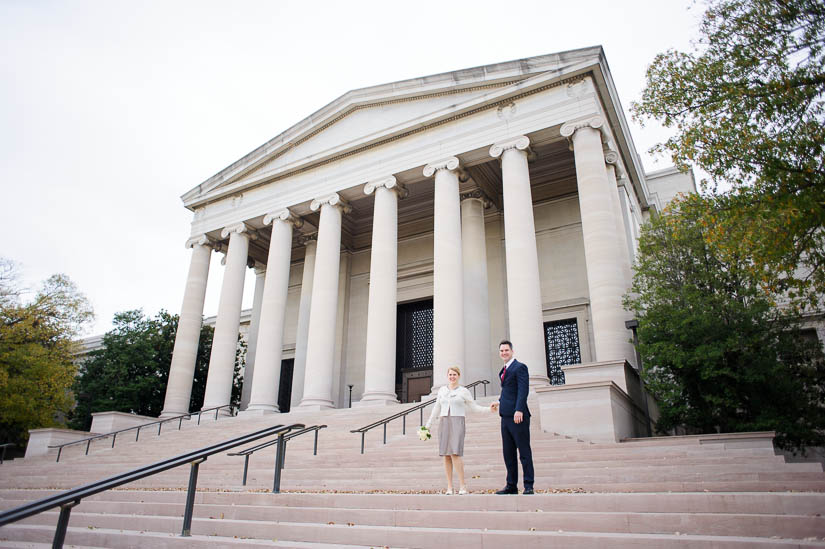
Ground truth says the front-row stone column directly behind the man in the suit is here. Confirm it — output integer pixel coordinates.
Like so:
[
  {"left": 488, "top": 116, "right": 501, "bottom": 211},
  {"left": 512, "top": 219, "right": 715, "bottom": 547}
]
[{"left": 490, "top": 135, "right": 550, "bottom": 386}]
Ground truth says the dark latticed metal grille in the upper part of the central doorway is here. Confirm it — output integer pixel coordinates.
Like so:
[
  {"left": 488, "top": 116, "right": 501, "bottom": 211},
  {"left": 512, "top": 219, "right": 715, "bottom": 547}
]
[{"left": 396, "top": 299, "right": 433, "bottom": 383}]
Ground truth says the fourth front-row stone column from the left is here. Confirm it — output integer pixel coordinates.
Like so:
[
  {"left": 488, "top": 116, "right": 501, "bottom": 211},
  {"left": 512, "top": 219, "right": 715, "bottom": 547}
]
[{"left": 301, "top": 193, "right": 350, "bottom": 408}]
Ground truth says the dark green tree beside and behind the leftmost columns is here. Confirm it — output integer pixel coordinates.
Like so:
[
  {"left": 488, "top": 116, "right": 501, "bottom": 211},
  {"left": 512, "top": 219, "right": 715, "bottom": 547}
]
[{"left": 72, "top": 309, "right": 245, "bottom": 430}]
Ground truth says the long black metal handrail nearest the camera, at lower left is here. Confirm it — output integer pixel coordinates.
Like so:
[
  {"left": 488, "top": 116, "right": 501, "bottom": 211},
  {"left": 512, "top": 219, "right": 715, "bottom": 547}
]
[{"left": 0, "top": 423, "right": 304, "bottom": 549}]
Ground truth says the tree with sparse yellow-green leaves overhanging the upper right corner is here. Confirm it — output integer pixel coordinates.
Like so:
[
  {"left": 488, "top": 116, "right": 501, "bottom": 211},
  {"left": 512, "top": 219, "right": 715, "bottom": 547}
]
[{"left": 632, "top": 0, "right": 825, "bottom": 309}]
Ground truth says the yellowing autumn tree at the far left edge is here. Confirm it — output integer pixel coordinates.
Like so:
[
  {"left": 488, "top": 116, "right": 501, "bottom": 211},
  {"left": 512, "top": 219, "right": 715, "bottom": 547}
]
[{"left": 0, "top": 259, "right": 94, "bottom": 445}]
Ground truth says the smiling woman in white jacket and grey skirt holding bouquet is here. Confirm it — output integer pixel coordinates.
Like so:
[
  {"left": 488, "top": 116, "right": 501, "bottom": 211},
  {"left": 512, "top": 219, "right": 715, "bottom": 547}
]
[{"left": 427, "top": 366, "right": 490, "bottom": 494}]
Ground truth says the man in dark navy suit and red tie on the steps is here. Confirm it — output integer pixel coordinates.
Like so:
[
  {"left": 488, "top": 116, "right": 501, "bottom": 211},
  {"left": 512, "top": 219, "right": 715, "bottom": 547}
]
[{"left": 492, "top": 339, "right": 533, "bottom": 495}]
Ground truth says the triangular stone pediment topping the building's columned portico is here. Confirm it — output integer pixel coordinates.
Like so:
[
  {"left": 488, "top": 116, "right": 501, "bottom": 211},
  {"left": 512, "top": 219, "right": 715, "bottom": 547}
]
[{"left": 182, "top": 46, "right": 603, "bottom": 206}]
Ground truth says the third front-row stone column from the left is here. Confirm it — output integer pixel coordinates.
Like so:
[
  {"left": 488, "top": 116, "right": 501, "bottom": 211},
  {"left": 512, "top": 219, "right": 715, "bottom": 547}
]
[{"left": 248, "top": 210, "right": 303, "bottom": 413}]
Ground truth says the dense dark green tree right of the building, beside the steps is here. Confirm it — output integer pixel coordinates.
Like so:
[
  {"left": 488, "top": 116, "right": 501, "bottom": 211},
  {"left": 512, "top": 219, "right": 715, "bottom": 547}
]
[{"left": 625, "top": 195, "right": 825, "bottom": 449}]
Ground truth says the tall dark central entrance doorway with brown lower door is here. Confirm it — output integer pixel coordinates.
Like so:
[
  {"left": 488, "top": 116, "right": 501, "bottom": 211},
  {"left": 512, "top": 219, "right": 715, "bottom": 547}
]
[{"left": 395, "top": 299, "right": 433, "bottom": 402}]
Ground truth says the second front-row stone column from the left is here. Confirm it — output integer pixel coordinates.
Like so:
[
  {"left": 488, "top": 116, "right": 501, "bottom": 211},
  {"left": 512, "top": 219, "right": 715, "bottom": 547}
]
[{"left": 203, "top": 223, "right": 251, "bottom": 409}]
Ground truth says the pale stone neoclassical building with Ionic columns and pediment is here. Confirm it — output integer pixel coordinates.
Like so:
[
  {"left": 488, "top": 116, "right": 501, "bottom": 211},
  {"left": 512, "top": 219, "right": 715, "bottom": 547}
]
[{"left": 158, "top": 47, "right": 695, "bottom": 432}]
